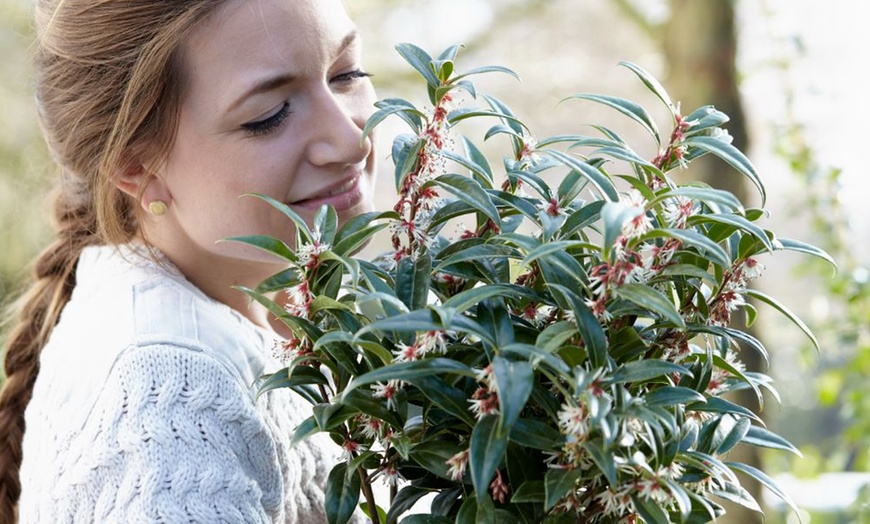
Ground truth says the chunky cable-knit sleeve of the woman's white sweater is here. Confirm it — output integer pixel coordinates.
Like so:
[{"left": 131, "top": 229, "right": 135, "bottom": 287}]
[{"left": 44, "top": 345, "right": 283, "bottom": 523}]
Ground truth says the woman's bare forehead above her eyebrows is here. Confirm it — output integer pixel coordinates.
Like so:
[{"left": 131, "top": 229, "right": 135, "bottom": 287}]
[{"left": 181, "top": 0, "right": 354, "bottom": 106}]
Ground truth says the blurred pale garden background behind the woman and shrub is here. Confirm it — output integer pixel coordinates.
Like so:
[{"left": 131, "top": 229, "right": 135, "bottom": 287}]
[{"left": 0, "top": 0, "right": 870, "bottom": 523}]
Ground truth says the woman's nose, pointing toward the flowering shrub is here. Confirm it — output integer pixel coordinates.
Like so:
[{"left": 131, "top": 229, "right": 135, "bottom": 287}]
[{"left": 308, "top": 89, "right": 372, "bottom": 166}]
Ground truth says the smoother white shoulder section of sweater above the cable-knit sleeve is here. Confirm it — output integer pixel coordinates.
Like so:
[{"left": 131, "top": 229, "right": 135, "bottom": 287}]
[{"left": 29, "top": 246, "right": 267, "bottom": 438}]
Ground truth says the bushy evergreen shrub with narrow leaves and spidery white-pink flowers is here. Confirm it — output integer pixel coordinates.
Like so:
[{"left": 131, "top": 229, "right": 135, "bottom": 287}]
[{"left": 236, "top": 44, "right": 830, "bottom": 523}]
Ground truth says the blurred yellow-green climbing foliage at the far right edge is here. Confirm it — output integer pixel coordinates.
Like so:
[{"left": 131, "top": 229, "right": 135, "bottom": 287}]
[{"left": 777, "top": 44, "right": 870, "bottom": 473}]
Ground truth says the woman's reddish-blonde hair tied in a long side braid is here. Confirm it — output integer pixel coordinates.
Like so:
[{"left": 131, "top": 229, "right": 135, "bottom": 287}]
[{"left": 0, "top": 0, "right": 228, "bottom": 524}]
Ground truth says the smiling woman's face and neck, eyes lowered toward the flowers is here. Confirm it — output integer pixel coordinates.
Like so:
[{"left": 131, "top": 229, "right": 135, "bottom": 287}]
[{"left": 146, "top": 0, "right": 375, "bottom": 283}]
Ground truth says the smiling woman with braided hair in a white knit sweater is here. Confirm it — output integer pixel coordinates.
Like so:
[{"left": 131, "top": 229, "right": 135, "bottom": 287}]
[{"left": 0, "top": 0, "right": 375, "bottom": 523}]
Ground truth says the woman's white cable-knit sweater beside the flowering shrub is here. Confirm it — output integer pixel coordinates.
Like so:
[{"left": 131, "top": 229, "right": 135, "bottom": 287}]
[{"left": 19, "top": 247, "right": 348, "bottom": 523}]
